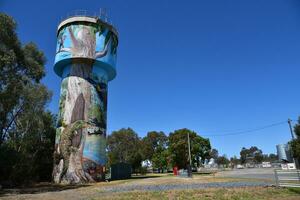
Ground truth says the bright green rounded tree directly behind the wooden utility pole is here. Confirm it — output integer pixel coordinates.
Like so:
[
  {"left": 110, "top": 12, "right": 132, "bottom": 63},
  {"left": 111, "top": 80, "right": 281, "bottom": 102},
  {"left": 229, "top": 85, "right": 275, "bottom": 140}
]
[{"left": 168, "top": 129, "right": 211, "bottom": 168}]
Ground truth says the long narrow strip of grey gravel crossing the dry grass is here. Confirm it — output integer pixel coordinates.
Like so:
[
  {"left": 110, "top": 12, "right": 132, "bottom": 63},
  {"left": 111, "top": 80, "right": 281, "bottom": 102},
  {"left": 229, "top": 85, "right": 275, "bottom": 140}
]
[{"left": 103, "top": 182, "right": 272, "bottom": 192}]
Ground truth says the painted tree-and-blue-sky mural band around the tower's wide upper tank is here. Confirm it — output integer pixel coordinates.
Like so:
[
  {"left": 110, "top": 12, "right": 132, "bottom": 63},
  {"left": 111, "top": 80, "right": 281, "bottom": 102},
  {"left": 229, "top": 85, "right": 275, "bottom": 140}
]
[{"left": 55, "top": 24, "right": 118, "bottom": 64}]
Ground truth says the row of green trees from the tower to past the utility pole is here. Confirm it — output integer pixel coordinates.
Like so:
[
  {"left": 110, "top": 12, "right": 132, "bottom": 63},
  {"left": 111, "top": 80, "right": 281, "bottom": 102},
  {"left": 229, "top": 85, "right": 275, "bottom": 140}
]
[{"left": 107, "top": 128, "right": 211, "bottom": 172}]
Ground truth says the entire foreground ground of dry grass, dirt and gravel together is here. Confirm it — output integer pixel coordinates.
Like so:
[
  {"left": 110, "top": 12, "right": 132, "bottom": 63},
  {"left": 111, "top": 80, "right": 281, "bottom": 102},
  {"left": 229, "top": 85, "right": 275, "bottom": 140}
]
[{"left": 0, "top": 174, "right": 300, "bottom": 200}]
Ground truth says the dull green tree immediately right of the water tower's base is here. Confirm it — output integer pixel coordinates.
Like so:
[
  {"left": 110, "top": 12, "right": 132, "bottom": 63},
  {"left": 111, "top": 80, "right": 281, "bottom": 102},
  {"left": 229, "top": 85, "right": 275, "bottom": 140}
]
[{"left": 107, "top": 128, "right": 143, "bottom": 171}]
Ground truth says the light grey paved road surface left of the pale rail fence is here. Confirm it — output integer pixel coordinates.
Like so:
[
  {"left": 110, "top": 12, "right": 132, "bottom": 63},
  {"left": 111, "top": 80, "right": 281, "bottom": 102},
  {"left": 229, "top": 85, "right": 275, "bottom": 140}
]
[{"left": 218, "top": 168, "right": 275, "bottom": 181}]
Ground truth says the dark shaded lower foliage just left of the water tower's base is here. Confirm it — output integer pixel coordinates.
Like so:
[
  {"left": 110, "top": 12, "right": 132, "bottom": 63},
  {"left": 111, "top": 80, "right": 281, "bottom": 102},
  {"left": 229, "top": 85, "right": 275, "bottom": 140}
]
[{"left": 0, "top": 112, "right": 55, "bottom": 185}]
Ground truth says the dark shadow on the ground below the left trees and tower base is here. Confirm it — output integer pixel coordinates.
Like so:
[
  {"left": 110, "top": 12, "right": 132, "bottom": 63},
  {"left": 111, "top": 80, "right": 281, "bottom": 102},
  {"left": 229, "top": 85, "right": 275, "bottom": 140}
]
[{"left": 0, "top": 183, "right": 90, "bottom": 197}]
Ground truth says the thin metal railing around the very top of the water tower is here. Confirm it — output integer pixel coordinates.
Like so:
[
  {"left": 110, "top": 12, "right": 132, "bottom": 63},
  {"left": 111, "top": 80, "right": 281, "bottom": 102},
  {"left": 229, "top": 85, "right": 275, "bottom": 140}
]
[{"left": 59, "top": 8, "right": 116, "bottom": 28}]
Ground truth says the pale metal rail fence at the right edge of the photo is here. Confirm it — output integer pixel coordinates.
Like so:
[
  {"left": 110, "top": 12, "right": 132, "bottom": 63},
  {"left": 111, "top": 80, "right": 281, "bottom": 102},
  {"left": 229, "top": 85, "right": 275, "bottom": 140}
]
[{"left": 274, "top": 169, "right": 300, "bottom": 187}]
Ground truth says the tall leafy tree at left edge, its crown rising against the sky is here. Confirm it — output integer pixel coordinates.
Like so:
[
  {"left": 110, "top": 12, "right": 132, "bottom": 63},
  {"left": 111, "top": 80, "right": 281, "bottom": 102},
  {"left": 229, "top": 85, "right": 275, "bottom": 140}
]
[{"left": 0, "top": 13, "right": 48, "bottom": 145}]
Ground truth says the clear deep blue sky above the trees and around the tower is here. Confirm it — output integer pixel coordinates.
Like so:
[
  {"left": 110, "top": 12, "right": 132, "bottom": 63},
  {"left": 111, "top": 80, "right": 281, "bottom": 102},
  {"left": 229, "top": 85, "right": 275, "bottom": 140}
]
[{"left": 0, "top": 0, "right": 300, "bottom": 156}]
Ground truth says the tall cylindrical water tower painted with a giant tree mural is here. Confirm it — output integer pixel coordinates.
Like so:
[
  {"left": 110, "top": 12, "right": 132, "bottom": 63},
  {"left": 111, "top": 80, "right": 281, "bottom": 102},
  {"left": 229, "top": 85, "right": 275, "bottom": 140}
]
[{"left": 53, "top": 10, "right": 118, "bottom": 183}]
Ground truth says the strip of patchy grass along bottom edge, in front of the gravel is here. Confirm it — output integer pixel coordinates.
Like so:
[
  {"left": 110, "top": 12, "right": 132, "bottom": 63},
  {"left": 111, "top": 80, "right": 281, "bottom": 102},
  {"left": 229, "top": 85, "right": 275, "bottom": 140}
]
[{"left": 94, "top": 187, "right": 300, "bottom": 200}]
